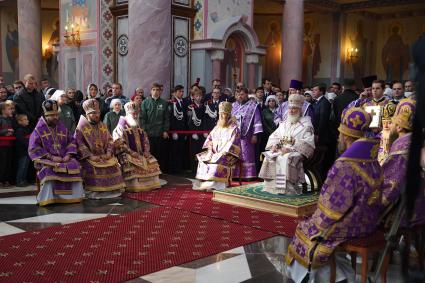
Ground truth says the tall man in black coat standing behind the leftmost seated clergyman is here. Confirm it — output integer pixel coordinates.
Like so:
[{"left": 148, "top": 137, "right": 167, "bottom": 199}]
[{"left": 13, "top": 74, "right": 44, "bottom": 130}]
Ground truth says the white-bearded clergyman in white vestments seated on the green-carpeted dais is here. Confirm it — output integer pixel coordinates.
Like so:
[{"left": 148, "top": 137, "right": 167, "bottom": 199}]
[{"left": 259, "top": 93, "right": 315, "bottom": 195}]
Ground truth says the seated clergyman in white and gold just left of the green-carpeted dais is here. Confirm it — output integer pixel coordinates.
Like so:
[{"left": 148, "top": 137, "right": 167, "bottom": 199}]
[{"left": 193, "top": 102, "right": 241, "bottom": 190}]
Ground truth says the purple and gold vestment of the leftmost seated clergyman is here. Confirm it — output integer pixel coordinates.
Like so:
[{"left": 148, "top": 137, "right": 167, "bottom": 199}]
[{"left": 28, "top": 117, "right": 82, "bottom": 195}]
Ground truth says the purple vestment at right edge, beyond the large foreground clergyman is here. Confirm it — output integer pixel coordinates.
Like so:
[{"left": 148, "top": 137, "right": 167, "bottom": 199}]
[{"left": 382, "top": 133, "right": 425, "bottom": 227}]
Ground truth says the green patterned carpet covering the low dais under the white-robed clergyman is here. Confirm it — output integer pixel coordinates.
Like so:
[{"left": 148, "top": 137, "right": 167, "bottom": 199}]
[{"left": 225, "top": 183, "right": 319, "bottom": 206}]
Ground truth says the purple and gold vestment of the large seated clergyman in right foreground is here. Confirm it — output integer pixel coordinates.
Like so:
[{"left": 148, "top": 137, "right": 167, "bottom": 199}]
[{"left": 286, "top": 139, "right": 383, "bottom": 268}]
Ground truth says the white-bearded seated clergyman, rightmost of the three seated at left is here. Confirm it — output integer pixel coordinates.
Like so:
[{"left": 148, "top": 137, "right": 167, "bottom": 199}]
[{"left": 112, "top": 102, "right": 161, "bottom": 192}]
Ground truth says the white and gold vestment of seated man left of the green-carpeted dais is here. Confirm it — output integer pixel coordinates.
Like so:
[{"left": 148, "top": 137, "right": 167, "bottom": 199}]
[{"left": 196, "top": 123, "right": 241, "bottom": 184}]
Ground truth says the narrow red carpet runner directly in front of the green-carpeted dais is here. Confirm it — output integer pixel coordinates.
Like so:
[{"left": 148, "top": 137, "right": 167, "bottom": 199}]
[{"left": 126, "top": 187, "right": 298, "bottom": 237}]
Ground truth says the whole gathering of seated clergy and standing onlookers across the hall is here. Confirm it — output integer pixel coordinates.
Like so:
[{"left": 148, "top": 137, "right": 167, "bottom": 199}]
[{"left": 0, "top": 69, "right": 425, "bottom": 282}]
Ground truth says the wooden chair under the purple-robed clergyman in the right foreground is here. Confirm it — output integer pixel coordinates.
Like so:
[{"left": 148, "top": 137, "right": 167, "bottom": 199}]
[{"left": 330, "top": 230, "right": 390, "bottom": 283}]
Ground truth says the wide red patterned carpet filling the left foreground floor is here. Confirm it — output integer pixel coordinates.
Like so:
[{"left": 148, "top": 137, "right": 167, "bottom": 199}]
[{"left": 0, "top": 207, "right": 273, "bottom": 282}]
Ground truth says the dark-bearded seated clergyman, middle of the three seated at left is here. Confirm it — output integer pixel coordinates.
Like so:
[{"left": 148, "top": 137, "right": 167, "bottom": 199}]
[{"left": 75, "top": 99, "right": 125, "bottom": 199}]
